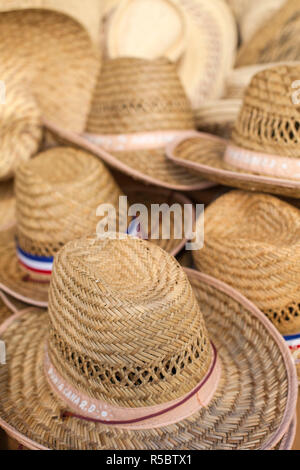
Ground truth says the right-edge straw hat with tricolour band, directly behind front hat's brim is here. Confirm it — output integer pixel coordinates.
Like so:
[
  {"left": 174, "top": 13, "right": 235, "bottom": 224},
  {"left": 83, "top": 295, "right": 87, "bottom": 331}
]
[{"left": 193, "top": 191, "right": 300, "bottom": 377}]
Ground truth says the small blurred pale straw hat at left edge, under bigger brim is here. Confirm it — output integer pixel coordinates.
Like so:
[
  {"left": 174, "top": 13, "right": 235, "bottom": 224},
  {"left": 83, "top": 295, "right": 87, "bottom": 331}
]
[{"left": 0, "top": 66, "right": 42, "bottom": 180}]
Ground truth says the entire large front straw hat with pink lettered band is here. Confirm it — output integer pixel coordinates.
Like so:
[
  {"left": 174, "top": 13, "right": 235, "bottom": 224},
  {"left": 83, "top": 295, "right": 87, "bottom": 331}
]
[{"left": 0, "top": 238, "right": 297, "bottom": 450}]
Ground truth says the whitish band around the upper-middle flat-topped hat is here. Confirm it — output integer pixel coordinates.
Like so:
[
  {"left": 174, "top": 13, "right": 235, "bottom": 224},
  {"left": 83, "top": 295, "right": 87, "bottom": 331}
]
[{"left": 84, "top": 129, "right": 194, "bottom": 152}]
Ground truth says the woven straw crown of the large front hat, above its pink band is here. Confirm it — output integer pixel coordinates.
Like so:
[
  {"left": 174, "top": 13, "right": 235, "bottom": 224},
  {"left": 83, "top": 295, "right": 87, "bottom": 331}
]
[{"left": 48, "top": 238, "right": 212, "bottom": 407}]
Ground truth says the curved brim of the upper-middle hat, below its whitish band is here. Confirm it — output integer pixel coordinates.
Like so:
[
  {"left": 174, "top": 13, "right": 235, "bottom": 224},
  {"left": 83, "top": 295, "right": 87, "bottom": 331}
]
[{"left": 43, "top": 119, "right": 215, "bottom": 191}]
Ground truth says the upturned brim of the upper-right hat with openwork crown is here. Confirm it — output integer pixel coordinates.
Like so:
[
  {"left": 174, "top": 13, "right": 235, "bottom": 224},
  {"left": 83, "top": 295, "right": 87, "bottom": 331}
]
[{"left": 166, "top": 132, "right": 300, "bottom": 198}]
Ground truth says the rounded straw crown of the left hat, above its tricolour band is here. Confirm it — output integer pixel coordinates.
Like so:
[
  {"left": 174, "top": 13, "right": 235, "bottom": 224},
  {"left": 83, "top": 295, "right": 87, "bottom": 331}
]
[{"left": 15, "top": 147, "right": 121, "bottom": 257}]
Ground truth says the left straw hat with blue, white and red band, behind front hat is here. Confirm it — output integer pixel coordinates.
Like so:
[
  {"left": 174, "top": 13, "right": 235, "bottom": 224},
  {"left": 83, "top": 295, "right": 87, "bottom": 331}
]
[{"left": 0, "top": 147, "right": 122, "bottom": 306}]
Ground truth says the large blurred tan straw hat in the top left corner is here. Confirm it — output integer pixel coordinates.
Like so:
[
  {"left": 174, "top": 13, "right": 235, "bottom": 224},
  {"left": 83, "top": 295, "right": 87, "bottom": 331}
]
[{"left": 0, "top": 0, "right": 100, "bottom": 132}]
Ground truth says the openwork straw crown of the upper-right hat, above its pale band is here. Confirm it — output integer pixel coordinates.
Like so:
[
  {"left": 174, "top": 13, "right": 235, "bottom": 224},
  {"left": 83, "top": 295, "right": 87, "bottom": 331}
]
[{"left": 232, "top": 66, "right": 300, "bottom": 158}]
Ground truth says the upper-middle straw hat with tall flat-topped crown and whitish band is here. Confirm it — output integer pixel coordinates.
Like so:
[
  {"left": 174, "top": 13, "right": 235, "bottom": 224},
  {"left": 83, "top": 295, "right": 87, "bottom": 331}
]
[{"left": 45, "top": 58, "right": 211, "bottom": 191}]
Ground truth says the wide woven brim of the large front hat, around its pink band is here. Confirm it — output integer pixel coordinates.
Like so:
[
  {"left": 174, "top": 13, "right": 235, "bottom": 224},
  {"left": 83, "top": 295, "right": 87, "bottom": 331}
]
[{"left": 0, "top": 270, "right": 298, "bottom": 450}]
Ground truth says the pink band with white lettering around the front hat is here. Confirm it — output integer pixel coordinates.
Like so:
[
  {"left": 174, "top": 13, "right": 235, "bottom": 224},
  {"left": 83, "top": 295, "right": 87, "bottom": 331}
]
[{"left": 44, "top": 345, "right": 221, "bottom": 429}]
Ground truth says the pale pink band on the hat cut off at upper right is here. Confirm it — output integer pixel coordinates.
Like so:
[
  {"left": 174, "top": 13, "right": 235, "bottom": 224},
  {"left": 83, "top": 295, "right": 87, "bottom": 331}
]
[{"left": 224, "top": 145, "right": 300, "bottom": 180}]
